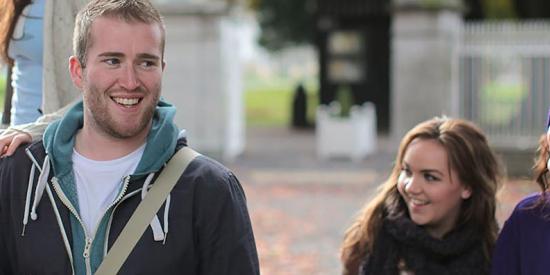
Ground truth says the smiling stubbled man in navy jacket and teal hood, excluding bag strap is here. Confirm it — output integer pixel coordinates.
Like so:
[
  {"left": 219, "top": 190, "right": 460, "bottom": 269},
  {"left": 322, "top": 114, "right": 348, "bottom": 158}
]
[{"left": 0, "top": 0, "right": 259, "bottom": 274}]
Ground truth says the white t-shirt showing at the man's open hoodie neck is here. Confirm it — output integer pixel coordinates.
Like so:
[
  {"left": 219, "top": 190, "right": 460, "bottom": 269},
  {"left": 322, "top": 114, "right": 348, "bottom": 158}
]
[{"left": 72, "top": 144, "right": 145, "bottom": 235}]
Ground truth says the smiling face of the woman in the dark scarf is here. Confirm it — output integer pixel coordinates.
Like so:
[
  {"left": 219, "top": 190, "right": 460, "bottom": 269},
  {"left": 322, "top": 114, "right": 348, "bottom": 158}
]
[{"left": 397, "top": 139, "right": 471, "bottom": 238}]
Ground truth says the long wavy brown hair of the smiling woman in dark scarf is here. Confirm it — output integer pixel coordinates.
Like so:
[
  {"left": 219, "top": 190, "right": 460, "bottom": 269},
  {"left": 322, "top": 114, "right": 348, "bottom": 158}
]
[{"left": 341, "top": 118, "right": 502, "bottom": 274}]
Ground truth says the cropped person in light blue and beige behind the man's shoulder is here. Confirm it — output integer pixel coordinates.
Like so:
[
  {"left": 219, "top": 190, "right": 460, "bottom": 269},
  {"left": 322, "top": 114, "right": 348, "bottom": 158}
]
[{"left": 0, "top": 0, "right": 87, "bottom": 125}]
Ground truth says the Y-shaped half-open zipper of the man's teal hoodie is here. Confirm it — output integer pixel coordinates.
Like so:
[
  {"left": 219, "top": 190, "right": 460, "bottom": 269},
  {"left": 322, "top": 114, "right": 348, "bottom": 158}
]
[{"left": 52, "top": 176, "right": 134, "bottom": 275}]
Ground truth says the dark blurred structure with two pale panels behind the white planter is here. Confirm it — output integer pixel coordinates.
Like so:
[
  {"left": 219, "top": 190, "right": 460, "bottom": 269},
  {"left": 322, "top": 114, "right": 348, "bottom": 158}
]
[{"left": 316, "top": 0, "right": 391, "bottom": 132}]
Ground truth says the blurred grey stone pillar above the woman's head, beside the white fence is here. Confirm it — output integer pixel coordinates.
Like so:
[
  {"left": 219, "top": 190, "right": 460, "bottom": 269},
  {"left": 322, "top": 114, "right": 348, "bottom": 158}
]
[{"left": 390, "top": 0, "right": 463, "bottom": 141}]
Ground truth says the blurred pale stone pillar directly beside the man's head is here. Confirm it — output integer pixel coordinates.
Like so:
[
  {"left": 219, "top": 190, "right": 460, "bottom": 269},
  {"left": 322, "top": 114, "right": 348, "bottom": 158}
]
[{"left": 156, "top": 0, "right": 245, "bottom": 160}]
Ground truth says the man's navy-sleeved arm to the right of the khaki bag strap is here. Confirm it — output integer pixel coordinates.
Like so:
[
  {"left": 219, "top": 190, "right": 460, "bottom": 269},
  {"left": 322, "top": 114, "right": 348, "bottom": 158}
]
[{"left": 196, "top": 167, "right": 260, "bottom": 275}]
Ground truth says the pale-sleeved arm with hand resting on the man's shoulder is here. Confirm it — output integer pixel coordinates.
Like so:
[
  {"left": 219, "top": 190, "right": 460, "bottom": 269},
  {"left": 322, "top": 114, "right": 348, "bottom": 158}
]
[{"left": 0, "top": 103, "right": 73, "bottom": 157}]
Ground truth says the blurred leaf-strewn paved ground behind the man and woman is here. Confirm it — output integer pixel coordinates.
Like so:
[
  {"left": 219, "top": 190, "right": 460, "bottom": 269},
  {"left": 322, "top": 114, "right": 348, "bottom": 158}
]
[{"left": 227, "top": 128, "right": 536, "bottom": 275}]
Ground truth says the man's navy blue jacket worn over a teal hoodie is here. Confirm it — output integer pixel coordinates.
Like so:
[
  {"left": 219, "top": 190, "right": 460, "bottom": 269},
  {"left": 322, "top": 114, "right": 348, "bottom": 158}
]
[{"left": 0, "top": 141, "right": 259, "bottom": 275}]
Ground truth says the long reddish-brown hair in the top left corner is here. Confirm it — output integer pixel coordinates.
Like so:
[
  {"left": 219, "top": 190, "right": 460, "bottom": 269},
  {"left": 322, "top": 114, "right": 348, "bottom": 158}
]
[{"left": 0, "top": 0, "right": 31, "bottom": 65}]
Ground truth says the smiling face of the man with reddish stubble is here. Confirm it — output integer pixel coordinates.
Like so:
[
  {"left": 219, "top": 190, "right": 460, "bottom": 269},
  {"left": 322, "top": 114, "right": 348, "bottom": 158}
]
[{"left": 70, "top": 17, "right": 164, "bottom": 139}]
